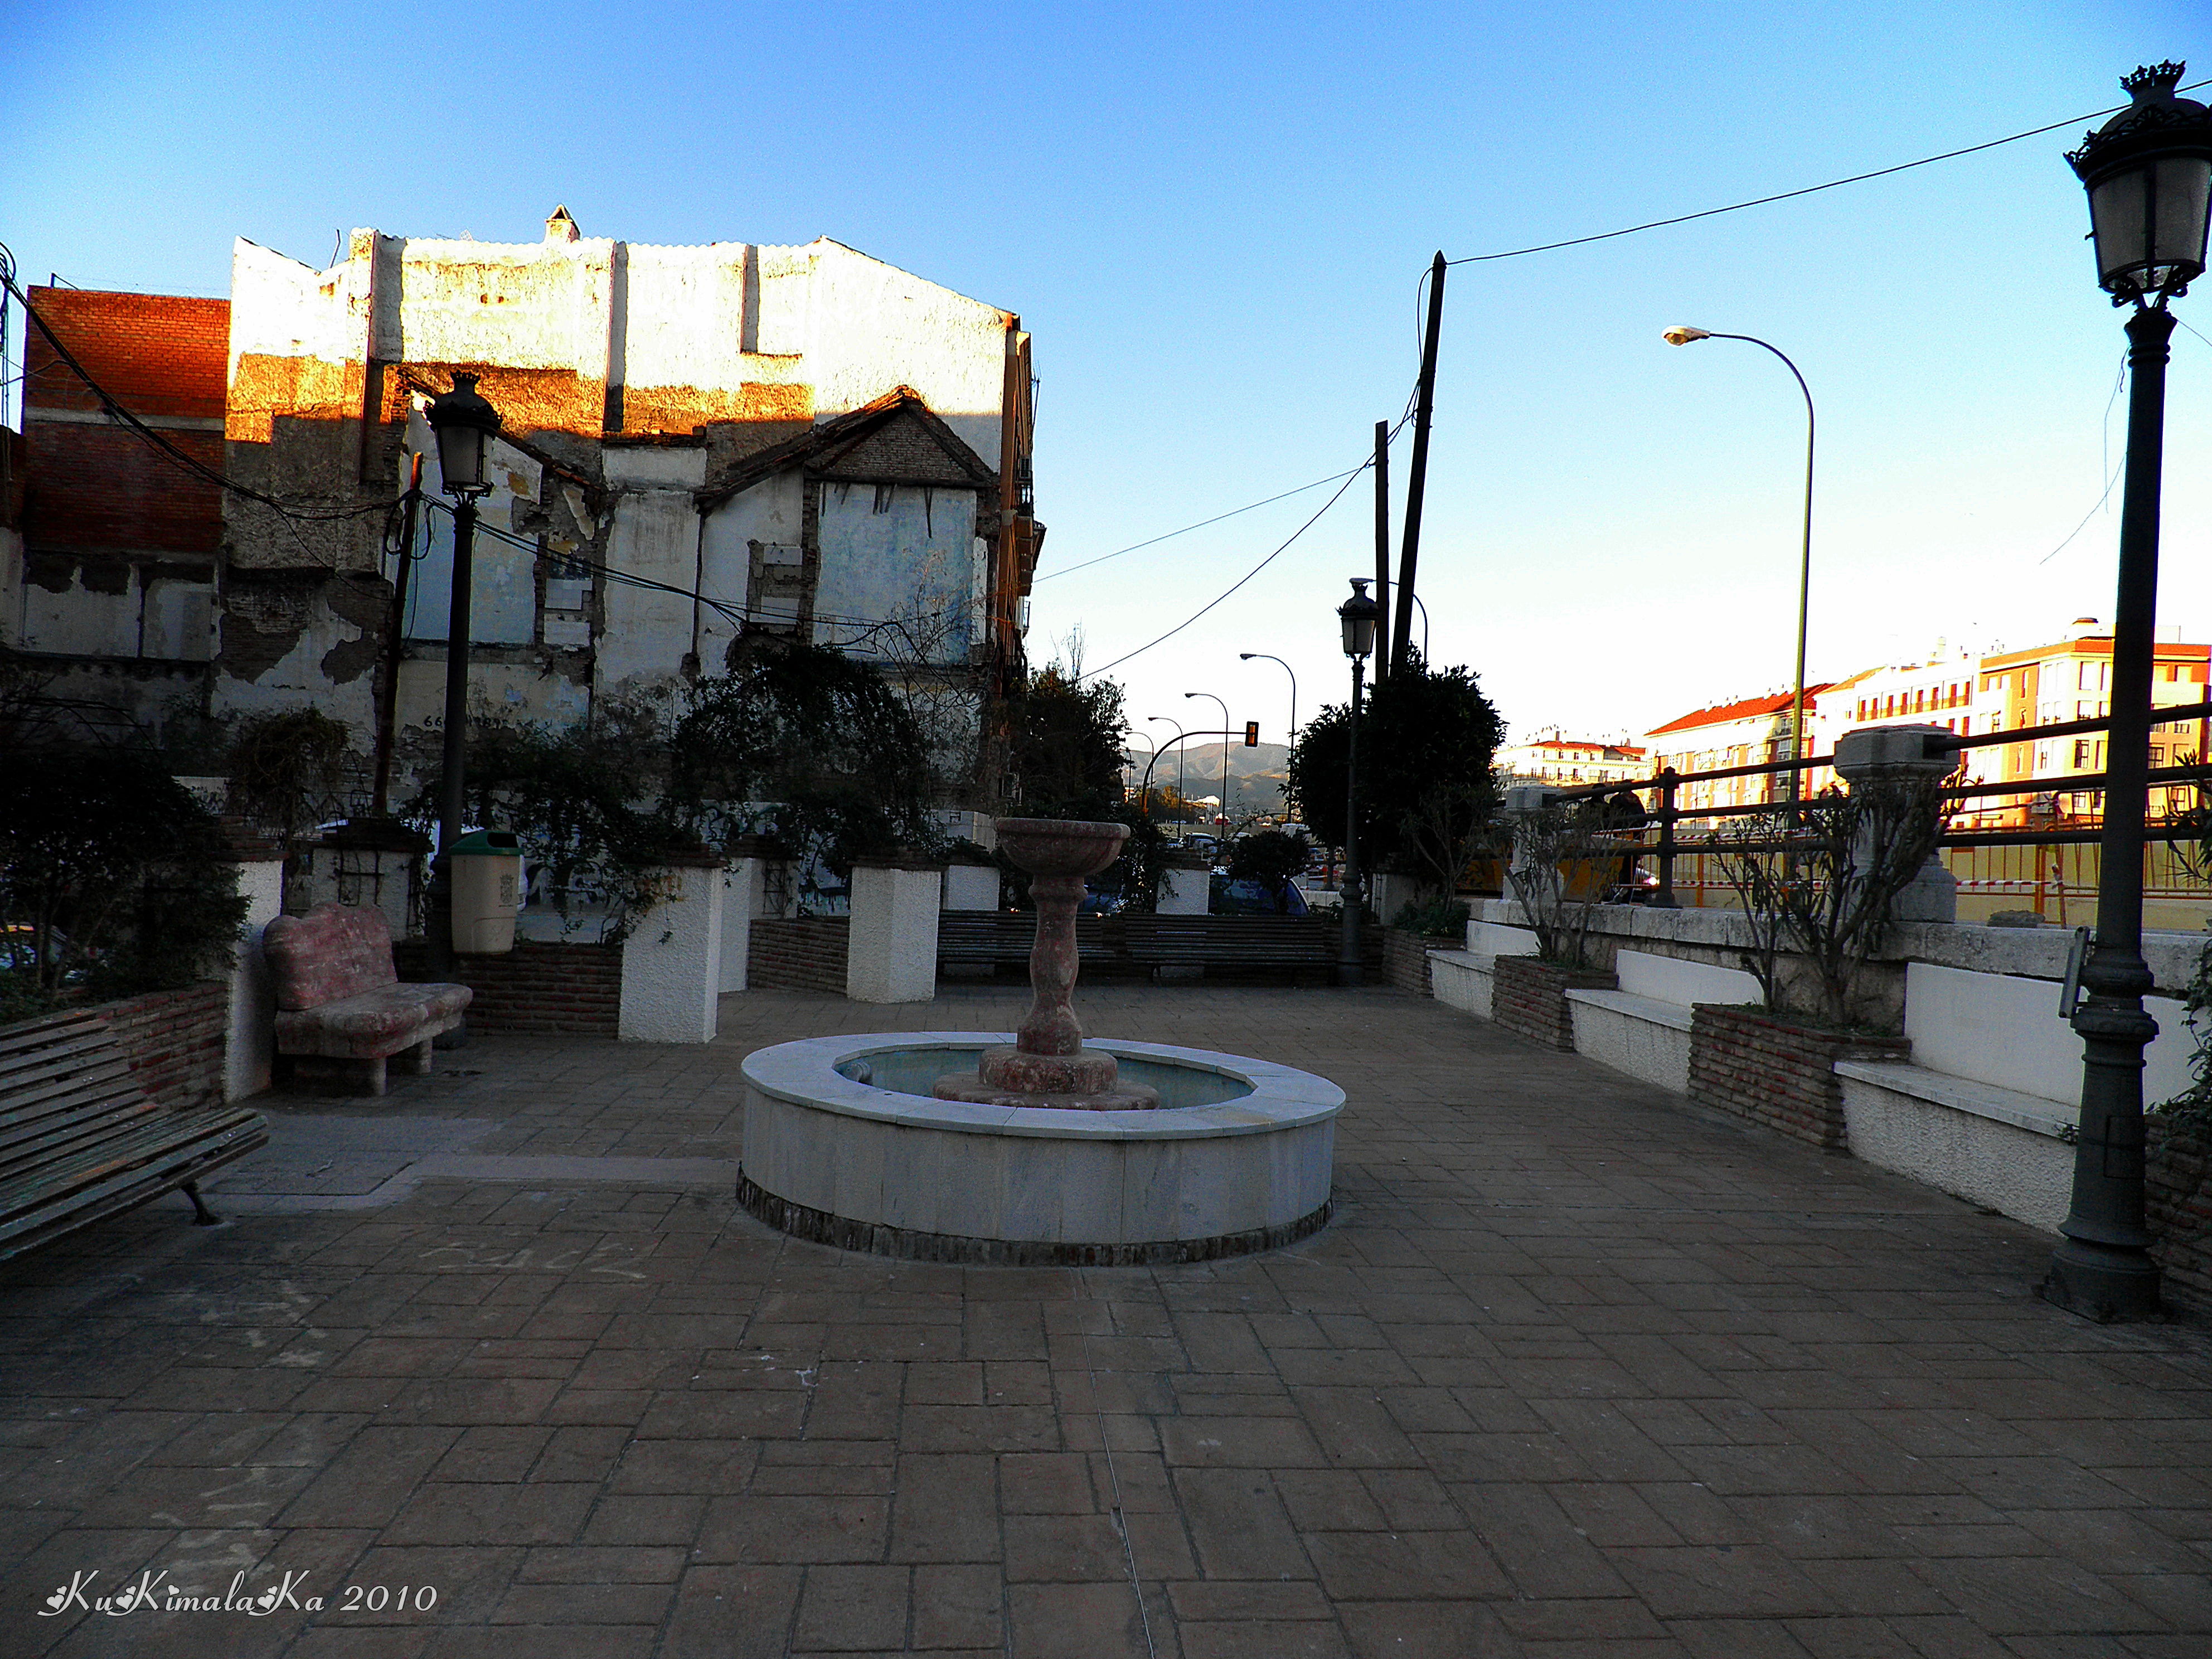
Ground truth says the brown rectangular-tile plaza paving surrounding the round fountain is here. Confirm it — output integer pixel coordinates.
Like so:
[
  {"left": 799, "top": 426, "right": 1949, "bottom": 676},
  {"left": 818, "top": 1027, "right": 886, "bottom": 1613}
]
[{"left": 0, "top": 987, "right": 2212, "bottom": 1659}]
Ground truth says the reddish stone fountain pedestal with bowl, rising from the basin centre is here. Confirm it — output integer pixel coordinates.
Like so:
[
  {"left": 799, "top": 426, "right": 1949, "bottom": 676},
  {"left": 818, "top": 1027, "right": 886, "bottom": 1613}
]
[{"left": 933, "top": 818, "right": 1159, "bottom": 1113}]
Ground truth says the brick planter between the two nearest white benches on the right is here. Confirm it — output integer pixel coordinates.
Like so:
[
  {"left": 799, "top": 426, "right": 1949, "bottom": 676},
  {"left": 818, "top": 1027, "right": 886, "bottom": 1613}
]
[{"left": 1681, "top": 1008, "right": 1911, "bottom": 1152}]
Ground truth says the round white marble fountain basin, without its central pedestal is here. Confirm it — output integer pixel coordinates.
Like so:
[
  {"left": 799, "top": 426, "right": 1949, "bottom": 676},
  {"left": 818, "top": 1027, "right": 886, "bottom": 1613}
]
[{"left": 739, "top": 1031, "right": 1345, "bottom": 1265}]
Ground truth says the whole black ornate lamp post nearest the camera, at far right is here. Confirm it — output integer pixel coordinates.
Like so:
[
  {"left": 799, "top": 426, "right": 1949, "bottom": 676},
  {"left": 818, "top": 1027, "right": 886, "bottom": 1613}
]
[{"left": 2041, "top": 64, "right": 2212, "bottom": 1321}]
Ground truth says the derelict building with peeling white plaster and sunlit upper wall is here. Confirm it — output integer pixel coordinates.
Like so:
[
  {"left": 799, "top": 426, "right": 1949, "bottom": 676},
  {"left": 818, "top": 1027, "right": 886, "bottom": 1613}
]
[{"left": 7, "top": 210, "right": 1042, "bottom": 805}]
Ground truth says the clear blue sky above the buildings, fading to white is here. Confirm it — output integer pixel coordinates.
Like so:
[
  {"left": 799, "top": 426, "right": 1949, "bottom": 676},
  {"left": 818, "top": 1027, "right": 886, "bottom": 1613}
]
[{"left": 0, "top": 0, "right": 2212, "bottom": 739}]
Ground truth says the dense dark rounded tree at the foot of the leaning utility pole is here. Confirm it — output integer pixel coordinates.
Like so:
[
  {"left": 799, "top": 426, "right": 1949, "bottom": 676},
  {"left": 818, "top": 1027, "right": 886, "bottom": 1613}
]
[{"left": 1285, "top": 653, "right": 1504, "bottom": 887}]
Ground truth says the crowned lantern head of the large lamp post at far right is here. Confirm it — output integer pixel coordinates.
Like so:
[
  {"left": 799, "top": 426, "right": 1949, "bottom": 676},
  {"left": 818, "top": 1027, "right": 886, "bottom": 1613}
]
[{"left": 2066, "top": 64, "right": 2212, "bottom": 305}]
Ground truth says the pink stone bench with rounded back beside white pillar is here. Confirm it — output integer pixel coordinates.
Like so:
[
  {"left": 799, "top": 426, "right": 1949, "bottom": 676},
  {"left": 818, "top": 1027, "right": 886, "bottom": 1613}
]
[{"left": 261, "top": 905, "right": 476, "bottom": 1095}]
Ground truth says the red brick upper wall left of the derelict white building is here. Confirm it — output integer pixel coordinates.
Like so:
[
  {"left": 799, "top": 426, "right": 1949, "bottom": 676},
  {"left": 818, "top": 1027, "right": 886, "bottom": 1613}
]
[{"left": 25, "top": 288, "right": 230, "bottom": 555}]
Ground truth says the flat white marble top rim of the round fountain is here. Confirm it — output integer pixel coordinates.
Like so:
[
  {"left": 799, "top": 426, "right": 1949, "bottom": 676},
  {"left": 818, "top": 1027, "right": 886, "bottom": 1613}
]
[{"left": 743, "top": 1031, "right": 1345, "bottom": 1141}]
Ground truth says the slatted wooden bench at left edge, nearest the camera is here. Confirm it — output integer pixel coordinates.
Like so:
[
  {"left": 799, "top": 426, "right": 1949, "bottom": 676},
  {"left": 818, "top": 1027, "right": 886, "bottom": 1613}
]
[{"left": 0, "top": 1013, "right": 270, "bottom": 1259}]
